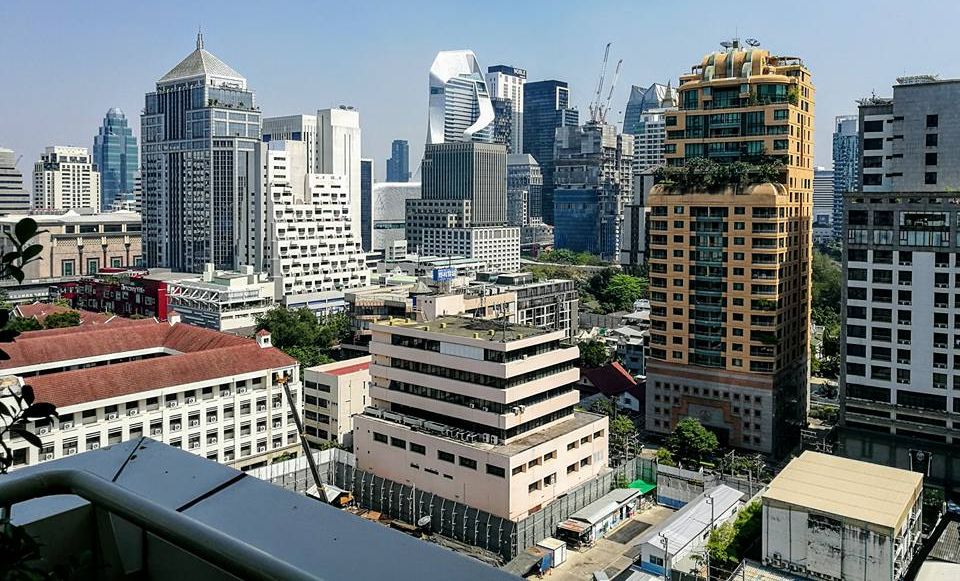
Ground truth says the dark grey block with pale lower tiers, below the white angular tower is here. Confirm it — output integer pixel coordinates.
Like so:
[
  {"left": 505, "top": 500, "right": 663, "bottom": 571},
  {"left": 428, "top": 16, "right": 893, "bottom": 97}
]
[{"left": 406, "top": 142, "right": 520, "bottom": 272}]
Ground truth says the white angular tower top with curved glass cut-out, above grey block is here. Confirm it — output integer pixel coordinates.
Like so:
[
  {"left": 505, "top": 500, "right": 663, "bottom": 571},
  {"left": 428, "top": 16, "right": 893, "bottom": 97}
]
[{"left": 427, "top": 50, "right": 494, "bottom": 144}]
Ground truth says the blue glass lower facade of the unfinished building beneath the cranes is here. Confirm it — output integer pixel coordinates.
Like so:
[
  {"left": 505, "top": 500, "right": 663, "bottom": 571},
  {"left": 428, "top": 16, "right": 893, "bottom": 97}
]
[{"left": 553, "top": 189, "right": 601, "bottom": 255}]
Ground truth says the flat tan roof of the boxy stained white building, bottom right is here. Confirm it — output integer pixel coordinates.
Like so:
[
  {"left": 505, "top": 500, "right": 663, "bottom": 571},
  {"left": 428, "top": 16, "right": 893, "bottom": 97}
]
[{"left": 763, "top": 451, "right": 923, "bottom": 530}]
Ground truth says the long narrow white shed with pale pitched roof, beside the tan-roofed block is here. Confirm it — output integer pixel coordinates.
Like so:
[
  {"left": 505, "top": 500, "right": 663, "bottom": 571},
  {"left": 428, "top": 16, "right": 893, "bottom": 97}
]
[{"left": 637, "top": 484, "right": 744, "bottom": 575}]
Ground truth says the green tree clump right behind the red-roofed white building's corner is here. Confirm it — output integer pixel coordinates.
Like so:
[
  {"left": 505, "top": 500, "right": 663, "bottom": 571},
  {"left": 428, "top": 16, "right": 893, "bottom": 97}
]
[{"left": 257, "top": 307, "right": 353, "bottom": 367}]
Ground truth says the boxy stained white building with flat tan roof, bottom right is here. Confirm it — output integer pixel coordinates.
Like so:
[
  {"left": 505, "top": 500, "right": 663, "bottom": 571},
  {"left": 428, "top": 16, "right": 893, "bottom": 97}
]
[{"left": 763, "top": 451, "right": 923, "bottom": 581}]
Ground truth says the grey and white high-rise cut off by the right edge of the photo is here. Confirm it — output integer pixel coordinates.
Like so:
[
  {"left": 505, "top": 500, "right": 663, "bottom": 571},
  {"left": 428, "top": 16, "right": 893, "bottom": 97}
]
[{"left": 840, "top": 76, "right": 960, "bottom": 489}]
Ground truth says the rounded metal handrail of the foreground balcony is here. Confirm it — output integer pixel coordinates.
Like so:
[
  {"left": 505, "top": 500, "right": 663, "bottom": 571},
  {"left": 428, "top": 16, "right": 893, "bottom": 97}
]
[{"left": 0, "top": 469, "right": 317, "bottom": 581}]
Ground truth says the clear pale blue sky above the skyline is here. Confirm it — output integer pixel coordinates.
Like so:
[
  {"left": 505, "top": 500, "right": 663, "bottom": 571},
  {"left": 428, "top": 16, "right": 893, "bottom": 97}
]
[{"left": 0, "top": 0, "right": 960, "bottom": 180}]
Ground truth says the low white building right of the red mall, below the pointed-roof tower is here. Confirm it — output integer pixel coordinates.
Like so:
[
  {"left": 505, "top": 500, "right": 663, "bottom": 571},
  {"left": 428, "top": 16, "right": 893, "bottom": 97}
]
[{"left": 167, "top": 264, "right": 276, "bottom": 333}]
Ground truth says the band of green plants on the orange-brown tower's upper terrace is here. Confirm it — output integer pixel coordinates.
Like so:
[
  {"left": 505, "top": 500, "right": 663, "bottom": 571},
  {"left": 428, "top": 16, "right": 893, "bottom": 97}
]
[{"left": 654, "top": 157, "right": 786, "bottom": 192}]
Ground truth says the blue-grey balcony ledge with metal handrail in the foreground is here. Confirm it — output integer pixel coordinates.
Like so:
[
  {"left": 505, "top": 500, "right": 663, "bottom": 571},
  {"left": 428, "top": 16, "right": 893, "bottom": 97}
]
[{"left": 0, "top": 439, "right": 512, "bottom": 581}]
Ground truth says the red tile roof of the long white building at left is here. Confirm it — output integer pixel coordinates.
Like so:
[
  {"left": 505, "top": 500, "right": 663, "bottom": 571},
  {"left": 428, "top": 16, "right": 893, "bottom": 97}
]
[{"left": 0, "top": 320, "right": 297, "bottom": 407}]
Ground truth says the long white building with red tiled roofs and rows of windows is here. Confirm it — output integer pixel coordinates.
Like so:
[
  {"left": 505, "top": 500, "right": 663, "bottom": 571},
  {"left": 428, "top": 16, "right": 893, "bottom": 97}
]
[{"left": 0, "top": 316, "right": 300, "bottom": 468}]
